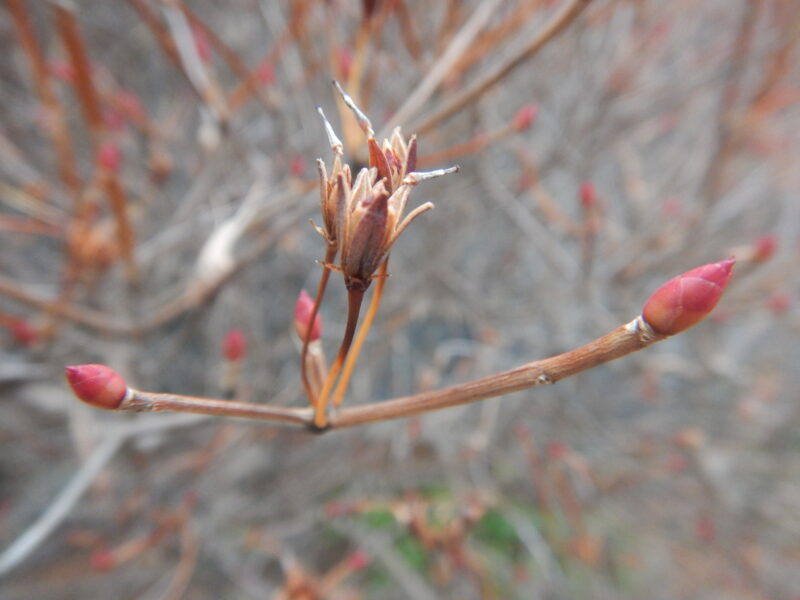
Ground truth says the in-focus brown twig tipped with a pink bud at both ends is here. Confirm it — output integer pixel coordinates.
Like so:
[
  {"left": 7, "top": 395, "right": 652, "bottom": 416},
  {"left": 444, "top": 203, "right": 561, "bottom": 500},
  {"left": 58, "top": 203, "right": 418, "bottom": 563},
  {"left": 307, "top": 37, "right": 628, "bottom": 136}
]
[{"left": 66, "top": 259, "right": 734, "bottom": 433}]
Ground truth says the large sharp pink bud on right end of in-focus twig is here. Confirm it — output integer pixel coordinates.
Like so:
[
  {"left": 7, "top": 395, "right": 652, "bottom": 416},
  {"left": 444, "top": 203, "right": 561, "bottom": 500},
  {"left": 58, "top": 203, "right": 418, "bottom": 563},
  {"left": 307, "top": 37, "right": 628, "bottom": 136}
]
[{"left": 642, "top": 258, "right": 736, "bottom": 335}]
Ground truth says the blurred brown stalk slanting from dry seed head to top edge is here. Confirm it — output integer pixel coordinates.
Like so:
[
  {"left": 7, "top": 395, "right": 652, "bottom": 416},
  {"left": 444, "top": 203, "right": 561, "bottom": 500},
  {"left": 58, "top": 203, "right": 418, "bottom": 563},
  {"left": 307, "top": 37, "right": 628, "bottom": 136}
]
[{"left": 412, "top": 0, "right": 591, "bottom": 134}]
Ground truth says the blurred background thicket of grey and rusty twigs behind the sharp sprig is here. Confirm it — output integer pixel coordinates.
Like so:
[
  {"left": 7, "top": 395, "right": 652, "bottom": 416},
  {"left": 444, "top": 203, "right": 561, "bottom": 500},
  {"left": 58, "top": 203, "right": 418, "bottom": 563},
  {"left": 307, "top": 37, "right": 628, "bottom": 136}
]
[{"left": 0, "top": 0, "right": 800, "bottom": 600}]
